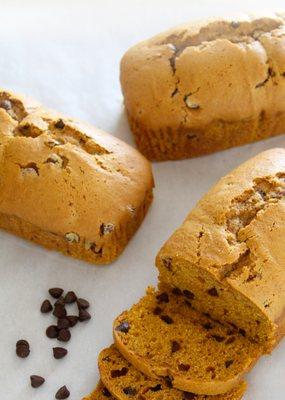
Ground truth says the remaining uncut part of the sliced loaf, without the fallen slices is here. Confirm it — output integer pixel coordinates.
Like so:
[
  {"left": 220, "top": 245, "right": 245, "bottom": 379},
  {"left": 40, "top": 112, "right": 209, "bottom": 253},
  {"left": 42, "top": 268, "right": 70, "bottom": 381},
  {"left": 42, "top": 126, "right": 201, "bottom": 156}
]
[{"left": 156, "top": 149, "right": 285, "bottom": 352}]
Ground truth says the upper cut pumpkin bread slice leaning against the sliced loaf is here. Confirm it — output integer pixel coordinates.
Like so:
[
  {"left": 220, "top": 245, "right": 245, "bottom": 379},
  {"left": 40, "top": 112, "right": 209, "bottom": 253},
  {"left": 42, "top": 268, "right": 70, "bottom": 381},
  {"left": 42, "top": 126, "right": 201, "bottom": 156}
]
[{"left": 113, "top": 286, "right": 260, "bottom": 395}]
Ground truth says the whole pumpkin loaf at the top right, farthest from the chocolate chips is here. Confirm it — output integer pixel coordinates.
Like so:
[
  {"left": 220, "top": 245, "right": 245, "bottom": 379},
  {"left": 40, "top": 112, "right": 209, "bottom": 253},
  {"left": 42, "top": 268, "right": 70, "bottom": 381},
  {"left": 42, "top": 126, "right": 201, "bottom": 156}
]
[{"left": 121, "top": 14, "right": 285, "bottom": 160}]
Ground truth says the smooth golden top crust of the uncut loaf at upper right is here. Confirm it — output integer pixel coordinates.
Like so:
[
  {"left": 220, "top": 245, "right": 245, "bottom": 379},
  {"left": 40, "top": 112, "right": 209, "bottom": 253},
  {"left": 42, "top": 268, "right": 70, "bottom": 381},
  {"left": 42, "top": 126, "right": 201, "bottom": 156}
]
[{"left": 121, "top": 14, "right": 285, "bottom": 130}]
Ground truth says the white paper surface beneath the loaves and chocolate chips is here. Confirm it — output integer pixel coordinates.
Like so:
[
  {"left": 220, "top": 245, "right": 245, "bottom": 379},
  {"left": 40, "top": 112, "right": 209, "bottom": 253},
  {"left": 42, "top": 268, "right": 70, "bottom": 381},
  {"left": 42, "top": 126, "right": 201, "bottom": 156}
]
[{"left": 0, "top": 0, "right": 285, "bottom": 400}]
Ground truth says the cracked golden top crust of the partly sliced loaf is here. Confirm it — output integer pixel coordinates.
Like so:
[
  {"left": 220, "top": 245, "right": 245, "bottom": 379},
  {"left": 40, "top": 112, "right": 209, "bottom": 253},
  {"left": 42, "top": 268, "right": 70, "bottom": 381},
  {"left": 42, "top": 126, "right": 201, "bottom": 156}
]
[{"left": 157, "top": 149, "right": 285, "bottom": 323}]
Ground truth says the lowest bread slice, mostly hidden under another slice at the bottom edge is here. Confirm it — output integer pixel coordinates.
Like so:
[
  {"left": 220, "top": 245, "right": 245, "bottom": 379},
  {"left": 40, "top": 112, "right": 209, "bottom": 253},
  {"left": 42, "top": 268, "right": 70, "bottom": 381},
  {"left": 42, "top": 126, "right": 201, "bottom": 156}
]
[{"left": 97, "top": 346, "right": 246, "bottom": 400}]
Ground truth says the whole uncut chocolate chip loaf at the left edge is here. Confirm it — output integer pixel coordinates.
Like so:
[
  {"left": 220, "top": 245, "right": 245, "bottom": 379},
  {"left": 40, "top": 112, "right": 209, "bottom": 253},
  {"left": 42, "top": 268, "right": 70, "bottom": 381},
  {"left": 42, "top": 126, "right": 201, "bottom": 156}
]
[{"left": 0, "top": 91, "right": 153, "bottom": 264}]
